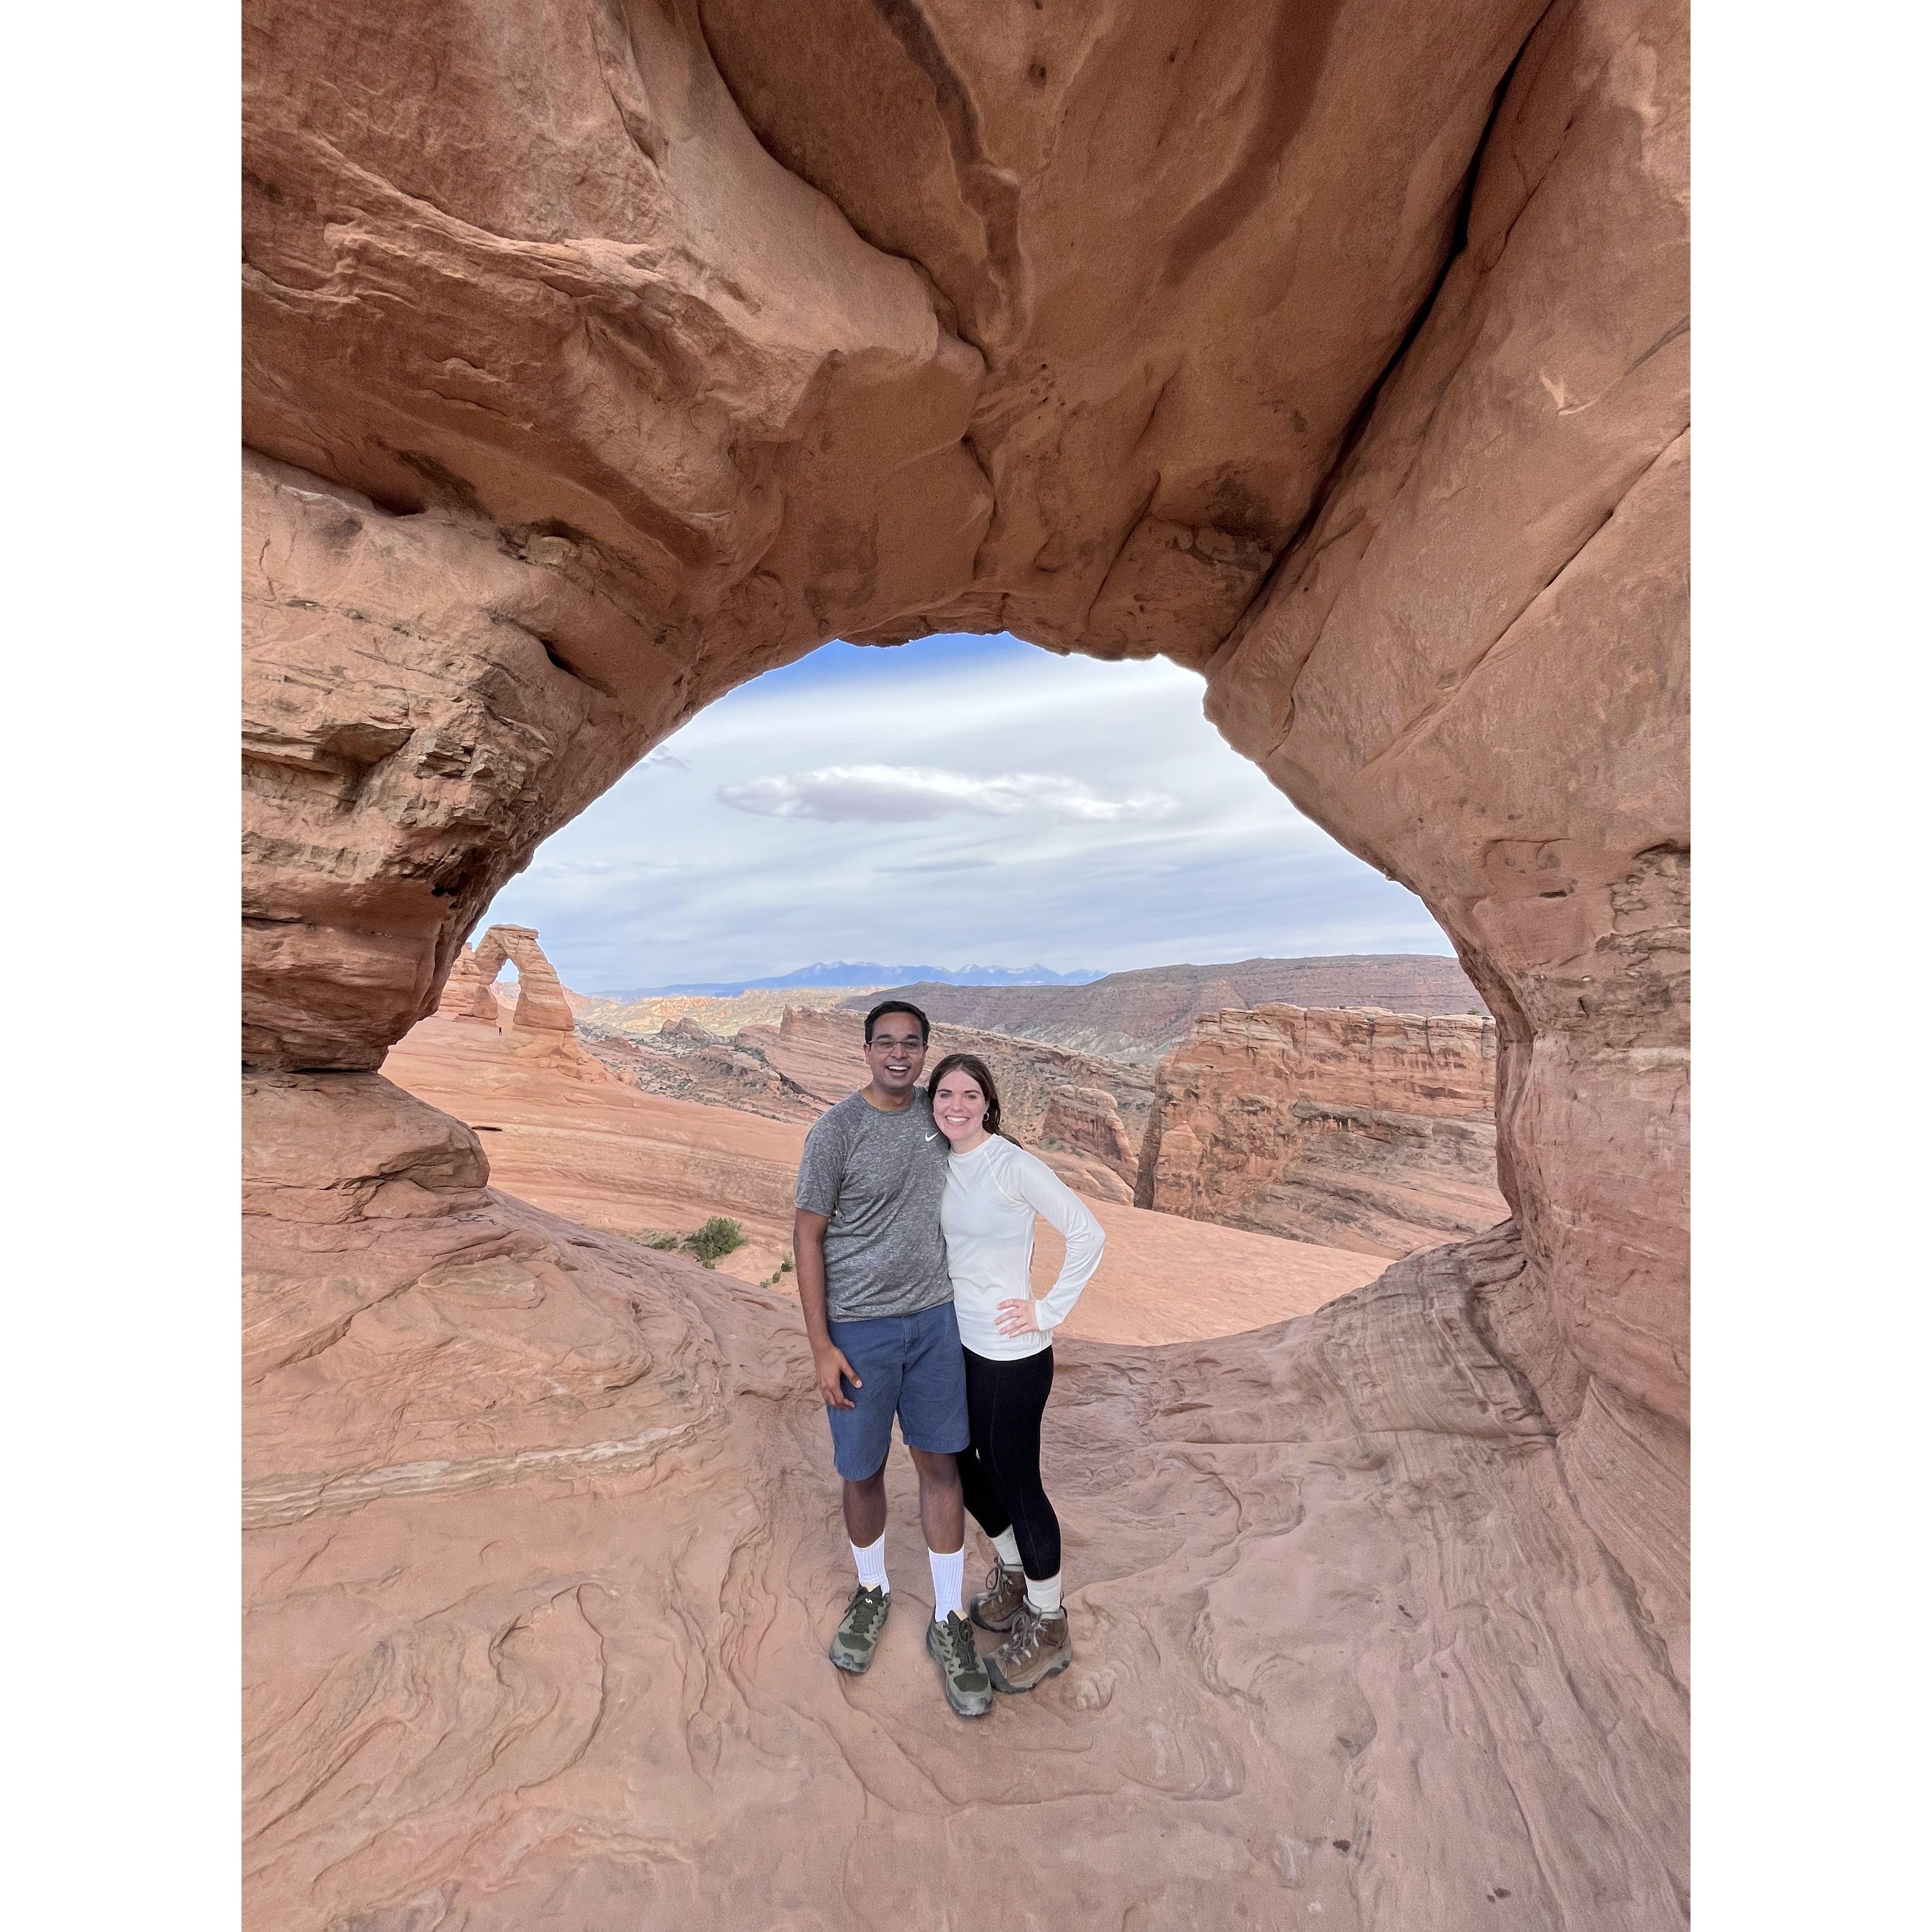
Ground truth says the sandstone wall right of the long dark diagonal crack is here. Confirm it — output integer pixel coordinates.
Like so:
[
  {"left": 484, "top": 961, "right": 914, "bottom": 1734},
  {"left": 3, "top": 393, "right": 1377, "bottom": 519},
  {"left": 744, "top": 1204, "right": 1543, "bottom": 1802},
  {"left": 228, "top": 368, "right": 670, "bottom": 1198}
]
[{"left": 1208, "top": 0, "right": 1690, "bottom": 1424}]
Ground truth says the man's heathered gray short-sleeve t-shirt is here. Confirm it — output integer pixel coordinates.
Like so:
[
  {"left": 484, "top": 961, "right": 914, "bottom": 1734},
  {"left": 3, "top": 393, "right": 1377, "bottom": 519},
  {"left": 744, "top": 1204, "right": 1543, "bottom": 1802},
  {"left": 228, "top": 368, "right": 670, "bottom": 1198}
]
[{"left": 798, "top": 1093, "right": 953, "bottom": 1322}]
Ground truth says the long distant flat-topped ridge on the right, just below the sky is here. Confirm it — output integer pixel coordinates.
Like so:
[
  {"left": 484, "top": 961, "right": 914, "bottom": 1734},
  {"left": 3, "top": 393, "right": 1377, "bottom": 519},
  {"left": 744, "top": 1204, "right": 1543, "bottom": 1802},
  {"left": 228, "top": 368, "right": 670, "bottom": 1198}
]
[{"left": 846, "top": 953, "right": 1482, "bottom": 1067}]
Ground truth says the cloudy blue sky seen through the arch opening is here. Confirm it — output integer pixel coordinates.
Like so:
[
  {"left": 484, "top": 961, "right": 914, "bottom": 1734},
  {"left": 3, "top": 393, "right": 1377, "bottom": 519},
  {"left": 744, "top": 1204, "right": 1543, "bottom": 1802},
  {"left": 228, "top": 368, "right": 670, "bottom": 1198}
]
[{"left": 489, "top": 636, "right": 1451, "bottom": 993}]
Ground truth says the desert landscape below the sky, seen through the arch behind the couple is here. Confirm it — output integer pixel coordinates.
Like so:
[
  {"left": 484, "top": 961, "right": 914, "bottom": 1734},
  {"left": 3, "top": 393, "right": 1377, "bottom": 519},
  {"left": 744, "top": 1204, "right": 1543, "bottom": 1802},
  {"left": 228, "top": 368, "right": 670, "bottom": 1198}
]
[{"left": 384, "top": 929, "right": 1509, "bottom": 1343}]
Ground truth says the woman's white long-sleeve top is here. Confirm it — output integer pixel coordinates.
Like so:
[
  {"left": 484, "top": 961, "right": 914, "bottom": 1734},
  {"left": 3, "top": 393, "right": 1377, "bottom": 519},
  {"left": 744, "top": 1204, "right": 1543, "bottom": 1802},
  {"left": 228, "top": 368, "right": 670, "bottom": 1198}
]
[{"left": 939, "top": 1134, "right": 1107, "bottom": 1362}]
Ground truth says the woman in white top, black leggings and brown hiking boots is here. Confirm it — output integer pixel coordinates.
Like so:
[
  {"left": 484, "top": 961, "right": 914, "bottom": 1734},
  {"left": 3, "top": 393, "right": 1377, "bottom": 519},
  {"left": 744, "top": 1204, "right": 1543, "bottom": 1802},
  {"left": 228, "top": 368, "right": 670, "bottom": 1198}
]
[{"left": 927, "top": 1053, "right": 1107, "bottom": 1690}]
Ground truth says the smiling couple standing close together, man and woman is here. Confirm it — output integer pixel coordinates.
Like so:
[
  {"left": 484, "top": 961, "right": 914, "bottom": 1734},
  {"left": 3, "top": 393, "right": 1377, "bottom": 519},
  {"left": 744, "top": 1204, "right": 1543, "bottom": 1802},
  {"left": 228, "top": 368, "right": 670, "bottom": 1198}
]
[{"left": 794, "top": 999, "right": 1107, "bottom": 1717}]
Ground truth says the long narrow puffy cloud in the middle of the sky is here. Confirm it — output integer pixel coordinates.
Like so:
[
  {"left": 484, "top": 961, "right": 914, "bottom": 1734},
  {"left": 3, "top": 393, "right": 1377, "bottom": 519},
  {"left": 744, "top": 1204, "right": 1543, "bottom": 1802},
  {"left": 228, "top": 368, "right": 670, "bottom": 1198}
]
[{"left": 717, "top": 765, "right": 1174, "bottom": 825}]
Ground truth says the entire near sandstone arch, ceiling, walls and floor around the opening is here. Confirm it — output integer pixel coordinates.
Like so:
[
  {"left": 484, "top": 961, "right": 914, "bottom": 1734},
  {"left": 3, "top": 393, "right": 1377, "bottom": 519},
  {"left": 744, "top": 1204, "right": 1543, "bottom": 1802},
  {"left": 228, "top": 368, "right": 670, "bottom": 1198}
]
[{"left": 243, "top": 0, "right": 1689, "bottom": 1932}]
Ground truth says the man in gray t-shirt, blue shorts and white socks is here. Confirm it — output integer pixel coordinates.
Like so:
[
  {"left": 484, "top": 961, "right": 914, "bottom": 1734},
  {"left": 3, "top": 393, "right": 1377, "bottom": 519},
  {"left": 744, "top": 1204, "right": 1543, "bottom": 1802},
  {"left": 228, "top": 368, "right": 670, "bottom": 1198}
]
[{"left": 792, "top": 999, "right": 993, "bottom": 1717}]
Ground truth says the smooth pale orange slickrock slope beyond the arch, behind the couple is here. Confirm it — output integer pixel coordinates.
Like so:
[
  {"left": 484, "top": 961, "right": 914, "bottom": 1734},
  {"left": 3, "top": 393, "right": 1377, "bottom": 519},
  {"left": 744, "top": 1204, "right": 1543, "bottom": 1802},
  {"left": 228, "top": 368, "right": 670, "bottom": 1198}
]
[{"left": 382, "top": 1020, "right": 1387, "bottom": 1343}]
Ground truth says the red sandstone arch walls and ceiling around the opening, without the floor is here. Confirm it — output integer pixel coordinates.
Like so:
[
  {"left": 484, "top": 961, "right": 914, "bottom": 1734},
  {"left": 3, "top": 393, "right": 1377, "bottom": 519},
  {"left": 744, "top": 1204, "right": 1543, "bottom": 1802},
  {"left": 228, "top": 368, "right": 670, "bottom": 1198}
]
[{"left": 243, "top": 0, "right": 1689, "bottom": 1924}]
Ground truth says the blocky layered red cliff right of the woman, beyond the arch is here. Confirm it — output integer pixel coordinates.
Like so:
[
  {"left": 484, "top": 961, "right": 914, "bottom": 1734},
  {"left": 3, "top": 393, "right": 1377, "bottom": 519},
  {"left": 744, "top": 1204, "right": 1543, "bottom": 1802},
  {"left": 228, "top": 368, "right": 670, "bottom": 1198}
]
[{"left": 1134, "top": 1007, "right": 1509, "bottom": 1260}]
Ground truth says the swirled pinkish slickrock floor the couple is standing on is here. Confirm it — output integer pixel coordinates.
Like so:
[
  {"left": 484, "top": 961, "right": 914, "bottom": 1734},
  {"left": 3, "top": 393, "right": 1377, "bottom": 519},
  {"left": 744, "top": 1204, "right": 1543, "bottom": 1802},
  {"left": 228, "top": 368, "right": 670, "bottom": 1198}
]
[{"left": 245, "top": 1081, "right": 1687, "bottom": 1932}]
